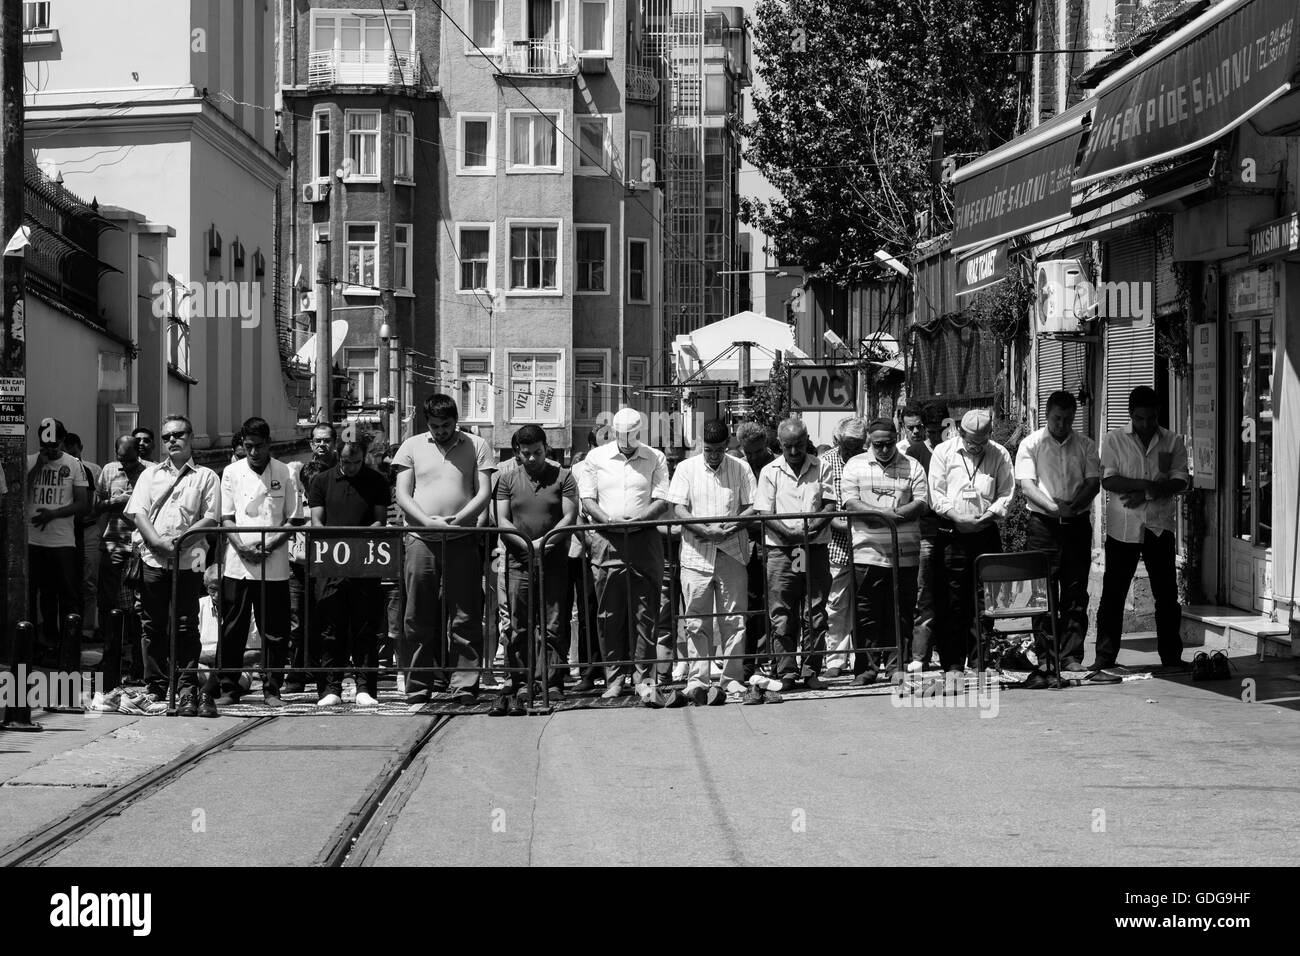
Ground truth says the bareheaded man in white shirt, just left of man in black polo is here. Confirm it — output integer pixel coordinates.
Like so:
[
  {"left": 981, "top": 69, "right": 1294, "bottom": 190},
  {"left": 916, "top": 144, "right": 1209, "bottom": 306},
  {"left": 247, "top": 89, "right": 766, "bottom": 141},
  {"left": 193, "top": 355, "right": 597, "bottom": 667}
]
[{"left": 208, "top": 418, "right": 306, "bottom": 708}]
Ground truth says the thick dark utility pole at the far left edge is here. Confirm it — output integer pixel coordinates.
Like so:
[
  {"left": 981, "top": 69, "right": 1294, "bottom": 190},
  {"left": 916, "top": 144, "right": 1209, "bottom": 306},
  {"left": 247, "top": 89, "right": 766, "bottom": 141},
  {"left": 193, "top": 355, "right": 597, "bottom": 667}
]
[{"left": 0, "top": 3, "right": 27, "bottom": 650}]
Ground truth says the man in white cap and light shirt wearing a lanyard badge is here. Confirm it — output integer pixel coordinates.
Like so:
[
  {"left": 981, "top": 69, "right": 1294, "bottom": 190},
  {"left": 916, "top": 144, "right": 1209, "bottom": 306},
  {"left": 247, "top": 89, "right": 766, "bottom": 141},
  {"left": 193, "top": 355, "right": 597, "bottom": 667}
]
[{"left": 930, "top": 408, "right": 1015, "bottom": 675}]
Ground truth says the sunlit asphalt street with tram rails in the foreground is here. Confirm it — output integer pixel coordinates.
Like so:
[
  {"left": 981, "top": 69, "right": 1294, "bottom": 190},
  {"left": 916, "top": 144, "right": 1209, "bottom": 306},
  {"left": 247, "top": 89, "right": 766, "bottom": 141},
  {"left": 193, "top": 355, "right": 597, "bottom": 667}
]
[{"left": 0, "top": 657, "right": 1300, "bottom": 866}]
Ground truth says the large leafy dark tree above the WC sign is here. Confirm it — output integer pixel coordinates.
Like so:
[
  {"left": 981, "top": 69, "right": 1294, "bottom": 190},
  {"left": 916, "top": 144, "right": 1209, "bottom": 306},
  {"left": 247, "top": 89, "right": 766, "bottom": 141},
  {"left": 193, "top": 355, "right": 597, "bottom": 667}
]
[{"left": 741, "top": 0, "right": 1034, "bottom": 282}]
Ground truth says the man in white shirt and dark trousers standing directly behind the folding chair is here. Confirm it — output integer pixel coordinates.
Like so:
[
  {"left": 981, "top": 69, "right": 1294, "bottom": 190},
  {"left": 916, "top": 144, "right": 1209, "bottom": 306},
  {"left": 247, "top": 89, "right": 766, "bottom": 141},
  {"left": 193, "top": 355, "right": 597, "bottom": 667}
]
[{"left": 1015, "top": 392, "right": 1114, "bottom": 688}]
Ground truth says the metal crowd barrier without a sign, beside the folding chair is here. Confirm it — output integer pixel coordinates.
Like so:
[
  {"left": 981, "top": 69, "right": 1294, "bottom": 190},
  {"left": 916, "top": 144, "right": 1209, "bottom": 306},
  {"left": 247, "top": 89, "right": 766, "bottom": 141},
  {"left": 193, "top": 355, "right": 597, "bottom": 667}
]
[{"left": 529, "top": 511, "right": 910, "bottom": 708}]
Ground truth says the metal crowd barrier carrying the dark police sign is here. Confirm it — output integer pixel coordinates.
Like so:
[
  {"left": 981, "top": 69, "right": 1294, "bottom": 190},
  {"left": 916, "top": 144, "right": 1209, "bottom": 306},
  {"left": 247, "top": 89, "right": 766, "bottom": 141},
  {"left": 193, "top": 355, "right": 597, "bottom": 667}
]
[{"left": 170, "top": 525, "right": 540, "bottom": 714}]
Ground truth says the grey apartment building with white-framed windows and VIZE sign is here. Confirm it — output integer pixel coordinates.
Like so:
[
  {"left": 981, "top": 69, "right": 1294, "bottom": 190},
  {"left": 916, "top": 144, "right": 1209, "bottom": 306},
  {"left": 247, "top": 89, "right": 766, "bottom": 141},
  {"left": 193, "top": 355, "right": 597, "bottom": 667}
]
[{"left": 439, "top": 0, "right": 663, "bottom": 451}]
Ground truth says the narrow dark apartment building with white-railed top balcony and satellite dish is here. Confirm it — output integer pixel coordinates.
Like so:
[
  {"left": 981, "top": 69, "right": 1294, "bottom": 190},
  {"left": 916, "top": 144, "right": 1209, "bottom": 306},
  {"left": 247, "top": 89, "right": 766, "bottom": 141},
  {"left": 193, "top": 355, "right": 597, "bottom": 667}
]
[{"left": 277, "top": 0, "right": 442, "bottom": 440}]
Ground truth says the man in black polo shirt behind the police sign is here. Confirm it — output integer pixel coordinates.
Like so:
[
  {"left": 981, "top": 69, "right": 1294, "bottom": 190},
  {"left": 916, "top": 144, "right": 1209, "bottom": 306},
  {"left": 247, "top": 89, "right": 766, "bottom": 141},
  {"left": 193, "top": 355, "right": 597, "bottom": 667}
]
[{"left": 307, "top": 441, "right": 393, "bottom": 708}]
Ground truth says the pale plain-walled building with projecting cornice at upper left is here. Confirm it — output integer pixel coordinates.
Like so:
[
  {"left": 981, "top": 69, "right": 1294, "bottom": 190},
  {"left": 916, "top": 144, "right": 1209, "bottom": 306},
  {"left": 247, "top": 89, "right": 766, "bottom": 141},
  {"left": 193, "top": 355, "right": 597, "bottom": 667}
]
[{"left": 23, "top": 0, "right": 298, "bottom": 447}]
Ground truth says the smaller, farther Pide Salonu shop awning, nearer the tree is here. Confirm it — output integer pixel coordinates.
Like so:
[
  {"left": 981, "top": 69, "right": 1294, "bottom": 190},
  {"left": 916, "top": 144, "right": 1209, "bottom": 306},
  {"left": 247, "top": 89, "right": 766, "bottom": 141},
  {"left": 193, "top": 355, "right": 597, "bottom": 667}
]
[{"left": 953, "top": 98, "right": 1096, "bottom": 254}]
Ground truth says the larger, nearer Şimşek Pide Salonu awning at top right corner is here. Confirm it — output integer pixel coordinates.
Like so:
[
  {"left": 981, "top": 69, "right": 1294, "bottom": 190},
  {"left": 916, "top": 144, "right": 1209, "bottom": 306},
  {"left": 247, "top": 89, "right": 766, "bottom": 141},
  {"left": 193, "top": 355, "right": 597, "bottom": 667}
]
[{"left": 1074, "top": 0, "right": 1300, "bottom": 186}]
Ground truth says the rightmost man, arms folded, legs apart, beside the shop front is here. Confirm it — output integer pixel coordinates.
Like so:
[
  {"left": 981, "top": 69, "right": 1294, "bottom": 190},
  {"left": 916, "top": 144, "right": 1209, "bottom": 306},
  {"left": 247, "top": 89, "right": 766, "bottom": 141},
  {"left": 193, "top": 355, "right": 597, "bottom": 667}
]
[{"left": 1089, "top": 385, "right": 1188, "bottom": 670}]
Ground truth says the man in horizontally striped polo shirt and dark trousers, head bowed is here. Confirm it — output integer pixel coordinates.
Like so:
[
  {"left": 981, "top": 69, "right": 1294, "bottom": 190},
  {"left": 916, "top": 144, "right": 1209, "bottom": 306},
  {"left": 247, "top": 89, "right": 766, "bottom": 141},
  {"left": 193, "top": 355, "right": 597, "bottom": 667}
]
[{"left": 840, "top": 419, "right": 930, "bottom": 687}]
